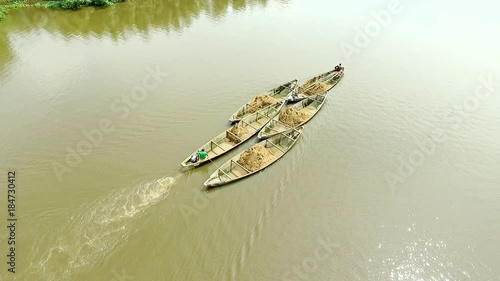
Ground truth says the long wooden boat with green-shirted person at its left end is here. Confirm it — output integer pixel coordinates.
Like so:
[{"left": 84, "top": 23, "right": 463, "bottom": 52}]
[{"left": 181, "top": 101, "right": 285, "bottom": 167}]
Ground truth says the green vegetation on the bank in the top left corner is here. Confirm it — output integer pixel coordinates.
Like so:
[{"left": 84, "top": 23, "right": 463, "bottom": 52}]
[{"left": 0, "top": 0, "right": 124, "bottom": 20}]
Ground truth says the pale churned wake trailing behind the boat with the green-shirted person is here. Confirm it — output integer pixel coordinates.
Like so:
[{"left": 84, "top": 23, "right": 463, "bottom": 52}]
[{"left": 20, "top": 176, "right": 179, "bottom": 280}]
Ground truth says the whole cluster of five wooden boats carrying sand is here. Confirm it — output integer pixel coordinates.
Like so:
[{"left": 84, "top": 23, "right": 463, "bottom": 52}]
[{"left": 181, "top": 66, "right": 344, "bottom": 188}]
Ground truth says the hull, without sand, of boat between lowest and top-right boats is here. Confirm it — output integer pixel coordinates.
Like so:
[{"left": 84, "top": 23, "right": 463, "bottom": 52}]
[{"left": 257, "top": 92, "right": 327, "bottom": 140}]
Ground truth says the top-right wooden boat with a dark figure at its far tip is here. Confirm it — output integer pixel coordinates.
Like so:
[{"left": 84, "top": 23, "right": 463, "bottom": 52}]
[{"left": 287, "top": 68, "right": 344, "bottom": 103}]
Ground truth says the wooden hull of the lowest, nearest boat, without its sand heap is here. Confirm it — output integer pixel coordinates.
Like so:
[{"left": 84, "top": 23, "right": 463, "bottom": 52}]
[{"left": 204, "top": 127, "right": 304, "bottom": 188}]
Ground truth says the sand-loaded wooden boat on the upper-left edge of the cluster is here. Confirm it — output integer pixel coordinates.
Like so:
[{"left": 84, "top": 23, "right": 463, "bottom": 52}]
[{"left": 229, "top": 80, "right": 297, "bottom": 122}]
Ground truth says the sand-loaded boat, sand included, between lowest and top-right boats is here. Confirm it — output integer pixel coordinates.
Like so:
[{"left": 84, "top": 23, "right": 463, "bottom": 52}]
[{"left": 257, "top": 92, "right": 327, "bottom": 140}]
